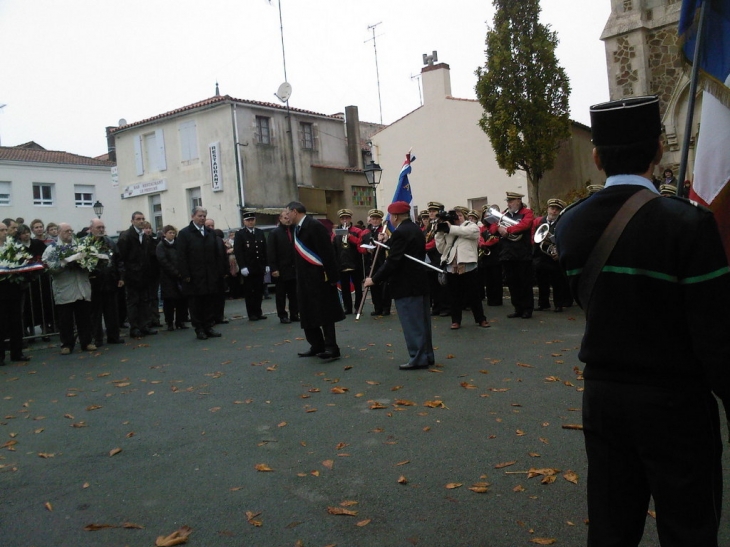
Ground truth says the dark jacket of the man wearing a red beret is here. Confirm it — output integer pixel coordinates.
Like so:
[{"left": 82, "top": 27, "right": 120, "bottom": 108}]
[{"left": 372, "top": 218, "right": 429, "bottom": 299}]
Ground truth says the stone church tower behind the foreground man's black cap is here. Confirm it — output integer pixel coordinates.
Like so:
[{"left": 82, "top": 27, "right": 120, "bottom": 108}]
[{"left": 601, "top": 0, "right": 702, "bottom": 176}]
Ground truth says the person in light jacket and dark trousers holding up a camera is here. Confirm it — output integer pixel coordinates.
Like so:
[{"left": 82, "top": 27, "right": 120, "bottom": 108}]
[{"left": 435, "top": 207, "right": 489, "bottom": 330}]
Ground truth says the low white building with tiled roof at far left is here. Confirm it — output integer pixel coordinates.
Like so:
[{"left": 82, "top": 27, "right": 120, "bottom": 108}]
[{"left": 0, "top": 142, "right": 119, "bottom": 234}]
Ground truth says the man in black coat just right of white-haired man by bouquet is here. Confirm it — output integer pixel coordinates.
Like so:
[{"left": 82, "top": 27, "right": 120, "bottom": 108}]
[{"left": 117, "top": 211, "right": 157, "bottom": 338}]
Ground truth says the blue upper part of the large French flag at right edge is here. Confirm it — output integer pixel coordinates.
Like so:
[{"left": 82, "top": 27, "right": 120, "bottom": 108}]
[{"left": 678, "top": 0, "right": 730, "bottom": 106}]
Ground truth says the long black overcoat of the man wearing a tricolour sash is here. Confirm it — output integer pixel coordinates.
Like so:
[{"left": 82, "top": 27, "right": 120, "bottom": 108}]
[{"left": 295, "top": 216, "right": 345, "bottom": 329}]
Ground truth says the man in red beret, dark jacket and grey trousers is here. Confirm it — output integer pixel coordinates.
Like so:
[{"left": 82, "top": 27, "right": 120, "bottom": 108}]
[{"left": 364, "top": 201, "right": 435, "bottom": 370}]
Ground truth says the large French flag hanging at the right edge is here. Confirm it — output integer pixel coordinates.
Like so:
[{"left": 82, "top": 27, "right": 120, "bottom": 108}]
[{"left": 679, "top": 0, "right": 730, "bottom": 261}]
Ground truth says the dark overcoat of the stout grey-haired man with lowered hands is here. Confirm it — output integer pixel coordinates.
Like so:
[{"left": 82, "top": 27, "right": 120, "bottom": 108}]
[{"left": 177, "top": 221, "right": 228, "bottom": 296}]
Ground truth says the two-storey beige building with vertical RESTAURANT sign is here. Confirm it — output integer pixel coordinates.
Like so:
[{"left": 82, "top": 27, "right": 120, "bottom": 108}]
[{"left": 108, "top": 95, "right": 379, "bottom": 229}]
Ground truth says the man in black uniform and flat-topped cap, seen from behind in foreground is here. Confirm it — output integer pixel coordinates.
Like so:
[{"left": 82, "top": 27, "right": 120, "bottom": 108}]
[{"left": 556, "top": 97, "right": 730, "bottom": 547}]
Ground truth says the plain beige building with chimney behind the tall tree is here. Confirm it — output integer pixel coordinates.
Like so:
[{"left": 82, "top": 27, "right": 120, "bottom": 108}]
[{"left": 372, "top": 63, "right": 604, "bottom": 214}]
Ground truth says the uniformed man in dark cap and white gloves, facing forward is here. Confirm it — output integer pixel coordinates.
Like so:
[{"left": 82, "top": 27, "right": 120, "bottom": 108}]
[{"left": 233, "top": 211, "right": 269, "bottom": 321}]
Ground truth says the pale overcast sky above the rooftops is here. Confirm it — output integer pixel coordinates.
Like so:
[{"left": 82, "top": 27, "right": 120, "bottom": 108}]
[{"left": 0, "top": 0, "right": 610, "bottom": 156}]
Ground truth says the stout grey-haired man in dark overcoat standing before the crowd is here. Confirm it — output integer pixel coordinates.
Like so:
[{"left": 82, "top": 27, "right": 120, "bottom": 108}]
[{"left": 177, "top": 206, "right": 228, "bottom": 340}]
